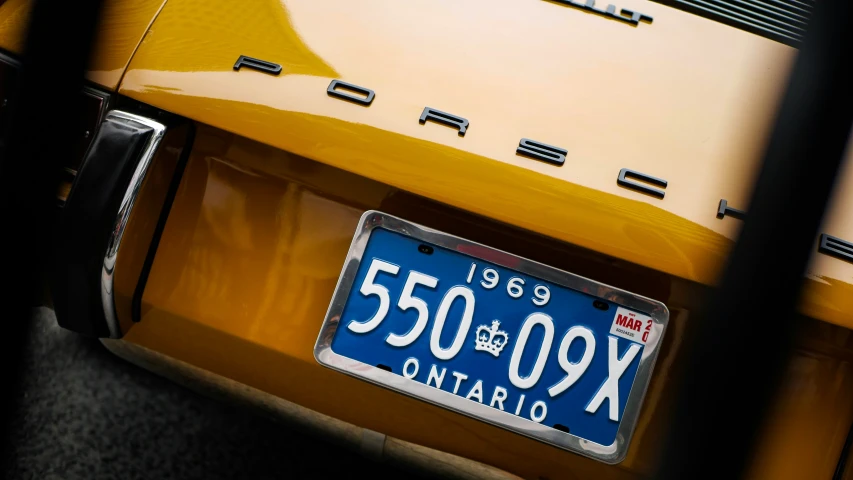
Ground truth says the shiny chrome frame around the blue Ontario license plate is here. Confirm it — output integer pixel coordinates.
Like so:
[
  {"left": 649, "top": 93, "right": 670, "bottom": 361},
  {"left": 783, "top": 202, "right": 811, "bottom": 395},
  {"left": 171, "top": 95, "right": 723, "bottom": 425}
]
[{"left": 314, "top": 210, "right": 669, "bottom": 464}]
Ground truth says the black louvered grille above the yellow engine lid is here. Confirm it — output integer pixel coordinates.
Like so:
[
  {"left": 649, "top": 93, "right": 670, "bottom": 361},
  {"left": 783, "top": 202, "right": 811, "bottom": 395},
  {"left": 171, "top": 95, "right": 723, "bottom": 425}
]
[{"left": 655, "top": 0, "right": 814, "bottom": 47}]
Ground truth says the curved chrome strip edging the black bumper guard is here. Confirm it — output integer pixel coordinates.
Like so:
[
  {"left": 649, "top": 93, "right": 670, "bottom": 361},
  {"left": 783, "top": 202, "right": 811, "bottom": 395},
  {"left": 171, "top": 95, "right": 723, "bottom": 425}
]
[{"left": 101, "top": 110, "right": 166, "bottom": 338}]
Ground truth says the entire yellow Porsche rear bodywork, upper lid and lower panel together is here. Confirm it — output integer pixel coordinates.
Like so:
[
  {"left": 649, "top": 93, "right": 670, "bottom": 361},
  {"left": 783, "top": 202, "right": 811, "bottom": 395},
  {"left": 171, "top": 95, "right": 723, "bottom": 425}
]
[{"left": 0, "top": 0, "right": 853, "bottom": 480}]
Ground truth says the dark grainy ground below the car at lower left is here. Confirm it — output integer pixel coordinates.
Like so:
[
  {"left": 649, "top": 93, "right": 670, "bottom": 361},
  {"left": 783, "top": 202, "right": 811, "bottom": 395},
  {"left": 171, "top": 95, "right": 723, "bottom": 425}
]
[{"left": 4, "top": 307, "right": 402, "bottom": 480}]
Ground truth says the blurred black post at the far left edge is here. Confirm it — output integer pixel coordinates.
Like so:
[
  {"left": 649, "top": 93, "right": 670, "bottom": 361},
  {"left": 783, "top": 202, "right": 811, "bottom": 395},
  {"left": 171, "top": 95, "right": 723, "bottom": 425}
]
[{"left": 0, "top": 0, "right": 102, "bottom": 460}]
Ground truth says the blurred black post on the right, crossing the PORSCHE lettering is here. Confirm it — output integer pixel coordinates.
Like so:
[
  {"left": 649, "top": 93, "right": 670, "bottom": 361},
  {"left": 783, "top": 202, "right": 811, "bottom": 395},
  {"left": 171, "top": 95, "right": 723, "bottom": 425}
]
[{"left": 659, "top": 0, "right": 853, "bottom": 479}]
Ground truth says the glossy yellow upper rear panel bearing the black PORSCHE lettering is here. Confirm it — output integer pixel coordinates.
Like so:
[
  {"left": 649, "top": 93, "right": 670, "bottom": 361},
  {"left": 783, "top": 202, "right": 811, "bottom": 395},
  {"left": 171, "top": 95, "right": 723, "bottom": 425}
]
[{"left": 115, "top": 0, "right": 853, "bottom": 326}]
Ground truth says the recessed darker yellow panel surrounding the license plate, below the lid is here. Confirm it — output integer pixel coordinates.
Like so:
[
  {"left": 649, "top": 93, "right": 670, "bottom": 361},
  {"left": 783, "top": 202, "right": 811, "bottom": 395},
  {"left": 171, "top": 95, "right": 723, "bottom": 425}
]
[{"left": 121, "top": 126, "right": 853, "bottom": 479}]
